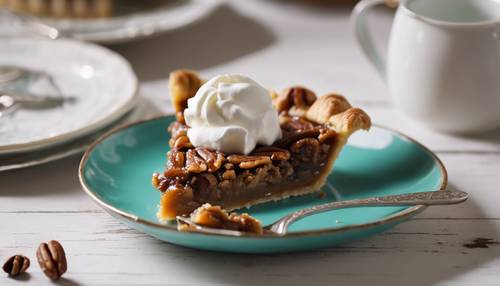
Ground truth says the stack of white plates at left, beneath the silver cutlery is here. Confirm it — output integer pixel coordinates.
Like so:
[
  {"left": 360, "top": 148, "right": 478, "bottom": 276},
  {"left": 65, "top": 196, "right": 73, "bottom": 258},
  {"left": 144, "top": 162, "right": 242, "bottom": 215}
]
[{"left": 0, "top": 37, "right": 142, "bottom": 171}]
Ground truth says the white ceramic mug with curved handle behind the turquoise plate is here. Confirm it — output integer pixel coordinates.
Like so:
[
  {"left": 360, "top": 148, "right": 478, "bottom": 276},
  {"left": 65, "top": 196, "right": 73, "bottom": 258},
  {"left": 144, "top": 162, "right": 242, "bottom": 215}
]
[{"left": 353, "top": 0, "right": 500, "bottom": 133}]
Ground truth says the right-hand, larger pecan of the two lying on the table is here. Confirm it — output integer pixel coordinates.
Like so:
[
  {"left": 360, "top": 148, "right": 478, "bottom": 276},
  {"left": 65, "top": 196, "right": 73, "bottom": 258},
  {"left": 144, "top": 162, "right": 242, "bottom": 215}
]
[{"left": 36, "top": 240, "right": 68, "bottom": 280}]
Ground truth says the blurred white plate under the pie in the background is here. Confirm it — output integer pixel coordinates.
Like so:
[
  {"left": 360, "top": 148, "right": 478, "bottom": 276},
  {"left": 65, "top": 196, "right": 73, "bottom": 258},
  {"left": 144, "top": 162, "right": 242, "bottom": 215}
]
[{"left": 0, "top": 0, "right": 220, "bottom": 43}]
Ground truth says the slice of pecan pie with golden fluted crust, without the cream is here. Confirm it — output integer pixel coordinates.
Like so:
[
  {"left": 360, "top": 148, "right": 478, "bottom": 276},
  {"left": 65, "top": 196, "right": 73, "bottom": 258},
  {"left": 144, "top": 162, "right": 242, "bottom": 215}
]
[{"left": 152, "top": 70, "right": 371, "bottom": 221}]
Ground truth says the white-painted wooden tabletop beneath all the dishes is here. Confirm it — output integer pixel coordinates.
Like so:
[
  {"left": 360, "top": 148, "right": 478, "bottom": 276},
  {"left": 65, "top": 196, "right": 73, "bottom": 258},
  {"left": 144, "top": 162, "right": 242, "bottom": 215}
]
[{"left": 0, "top": 0, "right": 500, "bottom": 285}]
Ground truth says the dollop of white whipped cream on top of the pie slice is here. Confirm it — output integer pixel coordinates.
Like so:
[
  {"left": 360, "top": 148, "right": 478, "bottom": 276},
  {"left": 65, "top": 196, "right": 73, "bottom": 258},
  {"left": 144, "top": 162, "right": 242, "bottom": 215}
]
[{"left": 184, "top": 74, "right": 281, "bottom": 154}]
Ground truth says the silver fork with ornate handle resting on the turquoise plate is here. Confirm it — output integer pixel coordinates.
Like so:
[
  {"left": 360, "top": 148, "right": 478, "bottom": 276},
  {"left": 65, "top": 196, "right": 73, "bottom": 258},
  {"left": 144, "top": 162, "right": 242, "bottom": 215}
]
[{"left": 177, "top": 191, "right": 469, "bottom": 236}]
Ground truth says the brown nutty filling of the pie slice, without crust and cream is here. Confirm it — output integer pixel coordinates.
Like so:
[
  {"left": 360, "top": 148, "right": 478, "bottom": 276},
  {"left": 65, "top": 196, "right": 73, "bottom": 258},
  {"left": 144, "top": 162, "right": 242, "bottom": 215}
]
[{"left": 153, "top": 115, "right": 337, "bottom": 219}]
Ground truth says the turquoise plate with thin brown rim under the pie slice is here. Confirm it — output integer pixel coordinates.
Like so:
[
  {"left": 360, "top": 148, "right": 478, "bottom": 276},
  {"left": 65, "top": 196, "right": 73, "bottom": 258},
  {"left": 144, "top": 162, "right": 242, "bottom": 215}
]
[{"left": 79, "top": 116, "right": 447, "bottom": 253}]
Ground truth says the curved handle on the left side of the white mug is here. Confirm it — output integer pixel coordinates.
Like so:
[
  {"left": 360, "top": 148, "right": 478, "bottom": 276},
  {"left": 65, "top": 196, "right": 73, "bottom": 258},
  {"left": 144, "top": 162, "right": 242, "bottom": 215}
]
[{"left": 351, "top": 0, "right": 394, "bottom": 79}]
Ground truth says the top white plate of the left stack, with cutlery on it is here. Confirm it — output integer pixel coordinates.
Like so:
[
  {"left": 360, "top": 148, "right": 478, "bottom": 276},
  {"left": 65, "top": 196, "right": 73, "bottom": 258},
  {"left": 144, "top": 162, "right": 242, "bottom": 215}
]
[{"left": 0, "top": 37, "right": 138, "bottom": 154}]
